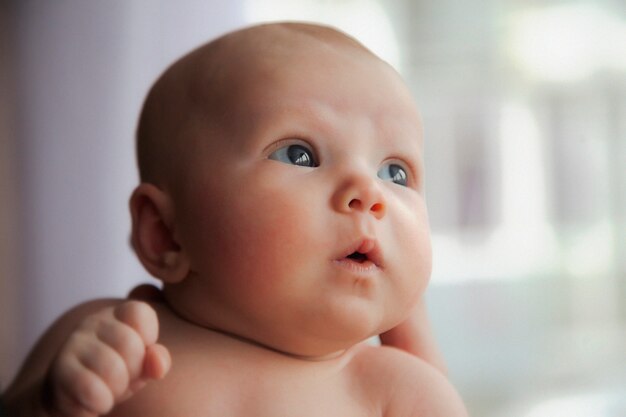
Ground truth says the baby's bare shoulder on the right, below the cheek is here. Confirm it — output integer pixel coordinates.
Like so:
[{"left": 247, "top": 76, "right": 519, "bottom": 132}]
[{"left": 354, "top": 346, "right": 468, "bottom": 417}]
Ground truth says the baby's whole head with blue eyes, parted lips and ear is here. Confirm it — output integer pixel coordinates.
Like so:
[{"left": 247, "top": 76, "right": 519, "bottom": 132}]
[{"left": 131, "top": 24, "right": 431, "bottom": 356}]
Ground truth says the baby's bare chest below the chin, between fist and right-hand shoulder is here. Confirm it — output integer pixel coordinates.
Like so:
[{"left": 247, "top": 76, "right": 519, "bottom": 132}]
[{"left": 152, "top": 354, "right": 382, "bottom": 417}]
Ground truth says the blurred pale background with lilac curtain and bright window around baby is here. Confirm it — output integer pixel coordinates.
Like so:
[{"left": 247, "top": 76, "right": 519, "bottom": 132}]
[{"left": 0, "top": 0, "right": 626, "bottom": 417}]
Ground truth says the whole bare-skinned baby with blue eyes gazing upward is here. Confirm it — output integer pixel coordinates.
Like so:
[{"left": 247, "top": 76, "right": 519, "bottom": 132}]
[{"left": 5, "top": 23, "right": 467, "bottom": 417}]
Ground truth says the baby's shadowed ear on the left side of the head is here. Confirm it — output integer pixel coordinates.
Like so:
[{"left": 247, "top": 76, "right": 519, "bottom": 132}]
[{"left": 130, "top": 183, "right": 190, "bottom": 284}]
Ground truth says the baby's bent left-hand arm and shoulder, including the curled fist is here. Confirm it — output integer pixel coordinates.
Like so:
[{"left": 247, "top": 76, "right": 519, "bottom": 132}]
[{"left": 4, "top": 301, "right": 170, "bottom": 417}]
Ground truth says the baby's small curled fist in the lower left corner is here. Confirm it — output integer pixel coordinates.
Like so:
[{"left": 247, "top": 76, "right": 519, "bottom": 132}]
[{"left": 44, "top": 301, "right": 171, "bottom": 417}]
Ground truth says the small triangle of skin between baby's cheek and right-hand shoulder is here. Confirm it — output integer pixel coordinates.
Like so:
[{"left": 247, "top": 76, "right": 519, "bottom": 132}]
[{"left": 380, "top": 298, "right": 447, "bottom": 375}]
